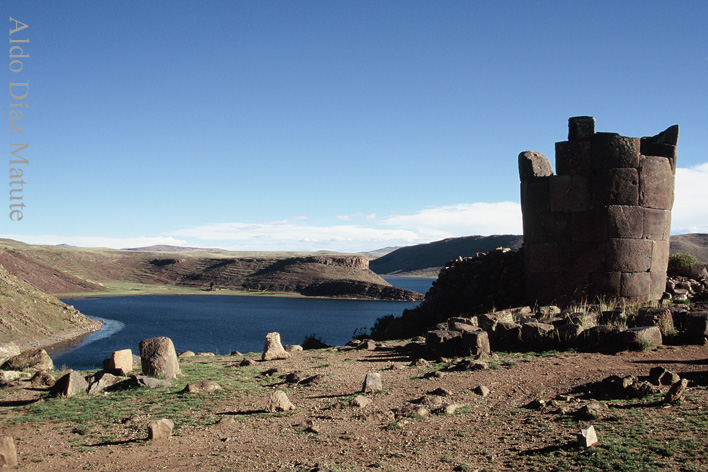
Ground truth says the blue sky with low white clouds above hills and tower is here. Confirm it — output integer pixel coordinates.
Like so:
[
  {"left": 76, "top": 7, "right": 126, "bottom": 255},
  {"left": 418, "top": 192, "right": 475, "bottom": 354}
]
[{"left": 5, "top": 0, "right": 708, "bottom": 251}]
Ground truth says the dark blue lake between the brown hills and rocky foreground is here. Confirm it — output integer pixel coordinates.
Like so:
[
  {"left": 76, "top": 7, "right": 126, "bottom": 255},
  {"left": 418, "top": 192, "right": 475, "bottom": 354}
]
[{"left": 49, "top": 277, "right": 433, "bottom": 370}]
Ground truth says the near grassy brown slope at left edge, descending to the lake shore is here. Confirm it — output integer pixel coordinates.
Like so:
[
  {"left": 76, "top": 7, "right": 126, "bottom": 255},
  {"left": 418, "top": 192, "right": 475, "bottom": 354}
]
[{"left": 0, "top": 266, "right": 101, "bottom": 346}]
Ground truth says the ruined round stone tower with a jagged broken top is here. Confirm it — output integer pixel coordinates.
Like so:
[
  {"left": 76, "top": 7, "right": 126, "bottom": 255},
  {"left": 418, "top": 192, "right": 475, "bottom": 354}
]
[{"left": 519, "top": 116, "right": 678, "bottom": 304}]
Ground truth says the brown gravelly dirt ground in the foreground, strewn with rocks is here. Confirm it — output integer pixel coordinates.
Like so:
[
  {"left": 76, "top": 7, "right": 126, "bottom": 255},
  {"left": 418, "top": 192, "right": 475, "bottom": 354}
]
[{"left": 0, "top": 344, "right": 708, "bottom": 471}]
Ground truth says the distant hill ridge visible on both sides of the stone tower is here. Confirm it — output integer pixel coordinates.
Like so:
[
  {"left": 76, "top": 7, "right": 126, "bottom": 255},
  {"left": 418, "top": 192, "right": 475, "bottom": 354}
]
[{"left": 370, "top": 233, "right": 708, "bottom": 277}]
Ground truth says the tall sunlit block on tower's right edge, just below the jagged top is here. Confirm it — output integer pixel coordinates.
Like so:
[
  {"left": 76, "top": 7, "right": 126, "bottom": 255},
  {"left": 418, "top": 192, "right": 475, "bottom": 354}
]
[{"left": 639, "top": 156, "right": 674, "bottom": 210}]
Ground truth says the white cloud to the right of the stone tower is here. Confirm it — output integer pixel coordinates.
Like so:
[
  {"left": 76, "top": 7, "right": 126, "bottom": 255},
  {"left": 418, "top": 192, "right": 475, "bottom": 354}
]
[{"left": 671, "top": 162, "right": 708, "bottom": 234}]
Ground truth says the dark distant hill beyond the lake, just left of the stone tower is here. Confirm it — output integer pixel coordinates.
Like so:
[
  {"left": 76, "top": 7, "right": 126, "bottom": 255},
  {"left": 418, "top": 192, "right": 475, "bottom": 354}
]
[{"left": 369, "top": 234, "right": 524, "bottom": 277}]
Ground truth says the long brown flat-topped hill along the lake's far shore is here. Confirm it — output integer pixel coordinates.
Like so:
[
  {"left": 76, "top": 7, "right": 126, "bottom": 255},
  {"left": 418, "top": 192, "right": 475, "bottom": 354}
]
[{"left": 0, "top": 240, "right": 422, "bottom": 300}]
